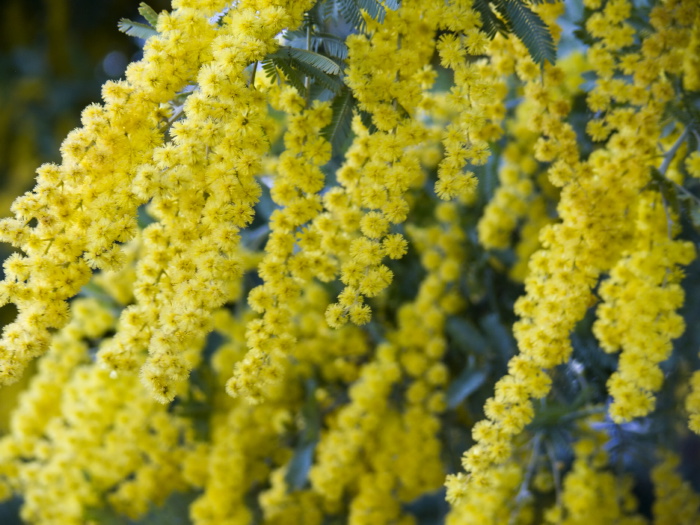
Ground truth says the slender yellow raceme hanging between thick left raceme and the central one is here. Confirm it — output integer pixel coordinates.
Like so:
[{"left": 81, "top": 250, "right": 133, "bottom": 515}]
[{"left": 227, "top": 91, "right": 334, "bottom": 402}]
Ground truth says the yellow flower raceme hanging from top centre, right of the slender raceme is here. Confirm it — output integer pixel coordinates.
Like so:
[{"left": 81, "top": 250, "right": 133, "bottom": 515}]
[{"left": 324, "top": 1, "right": 442, "bottom": 327}]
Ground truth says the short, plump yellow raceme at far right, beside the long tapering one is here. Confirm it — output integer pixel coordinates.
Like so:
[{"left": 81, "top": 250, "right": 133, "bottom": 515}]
[{"left": 593, "top": 193, "right": 695, "bottom": 422}]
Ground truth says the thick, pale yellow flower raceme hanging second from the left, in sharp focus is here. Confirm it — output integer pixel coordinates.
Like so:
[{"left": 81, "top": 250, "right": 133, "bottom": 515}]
[{"left": 100, "top": 2, "right": 309, "bottom": 402}]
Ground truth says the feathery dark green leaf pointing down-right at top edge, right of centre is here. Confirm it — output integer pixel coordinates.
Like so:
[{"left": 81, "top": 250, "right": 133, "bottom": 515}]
[{"left": 494, "top": 0, "right": 557, "bottom": 65}]
